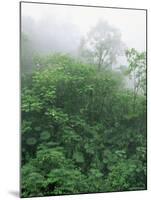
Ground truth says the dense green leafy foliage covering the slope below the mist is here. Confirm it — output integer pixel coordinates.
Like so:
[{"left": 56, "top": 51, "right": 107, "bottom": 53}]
[{"left": 21, "top": 54, "right": 146, "bottom": 197}]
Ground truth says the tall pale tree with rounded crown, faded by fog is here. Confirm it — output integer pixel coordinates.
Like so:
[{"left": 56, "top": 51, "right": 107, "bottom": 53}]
[{"left": 80, "top": 21, "right": 125, "bottom": 69}]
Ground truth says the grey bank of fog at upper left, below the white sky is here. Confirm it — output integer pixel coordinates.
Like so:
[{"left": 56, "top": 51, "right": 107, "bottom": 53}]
[{"left": 22, "top": 17, "right": 81, "bottom": 54}]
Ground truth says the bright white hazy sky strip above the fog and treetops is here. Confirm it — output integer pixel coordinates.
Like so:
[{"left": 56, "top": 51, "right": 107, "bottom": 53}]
[{"left": 22, "top": 3, "right": 146, "bottom": 51}]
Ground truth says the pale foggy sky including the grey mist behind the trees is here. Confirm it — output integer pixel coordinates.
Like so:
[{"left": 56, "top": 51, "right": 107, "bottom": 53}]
[{"left": 21, "top": 3, "right": 146, "bottom": 64}]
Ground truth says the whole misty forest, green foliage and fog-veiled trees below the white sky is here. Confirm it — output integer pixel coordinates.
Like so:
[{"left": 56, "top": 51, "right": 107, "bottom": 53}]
[{"left": 21, "top": 10, "right": 147, "bottom": 197}]
